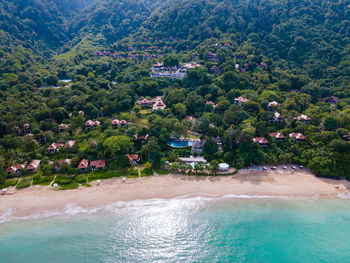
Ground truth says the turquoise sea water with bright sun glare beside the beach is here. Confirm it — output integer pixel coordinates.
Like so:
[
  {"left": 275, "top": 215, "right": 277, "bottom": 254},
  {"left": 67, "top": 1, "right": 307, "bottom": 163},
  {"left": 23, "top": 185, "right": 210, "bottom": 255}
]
[{"left": 0, "top": 197, "right": 350, "bottom": 263}]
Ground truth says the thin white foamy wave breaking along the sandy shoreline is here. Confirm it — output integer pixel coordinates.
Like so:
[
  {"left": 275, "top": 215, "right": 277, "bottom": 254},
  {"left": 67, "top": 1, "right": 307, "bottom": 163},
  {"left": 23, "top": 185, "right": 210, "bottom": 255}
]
[{"left": 0, "top": 193, "right": 344, "bottom": 224}]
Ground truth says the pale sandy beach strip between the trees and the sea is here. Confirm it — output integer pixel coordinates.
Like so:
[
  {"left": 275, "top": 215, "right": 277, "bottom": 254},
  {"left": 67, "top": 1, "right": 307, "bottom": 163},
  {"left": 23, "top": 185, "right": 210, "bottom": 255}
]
[{"left": 0, "top": 170, "right": 350, "bottom": 217}]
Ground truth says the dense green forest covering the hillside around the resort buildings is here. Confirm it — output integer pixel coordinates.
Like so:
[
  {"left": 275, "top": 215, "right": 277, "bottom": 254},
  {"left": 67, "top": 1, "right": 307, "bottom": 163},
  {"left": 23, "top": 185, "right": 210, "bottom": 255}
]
[{"left": 0, "top": 0, "right": 350, "bottom": 187}]
